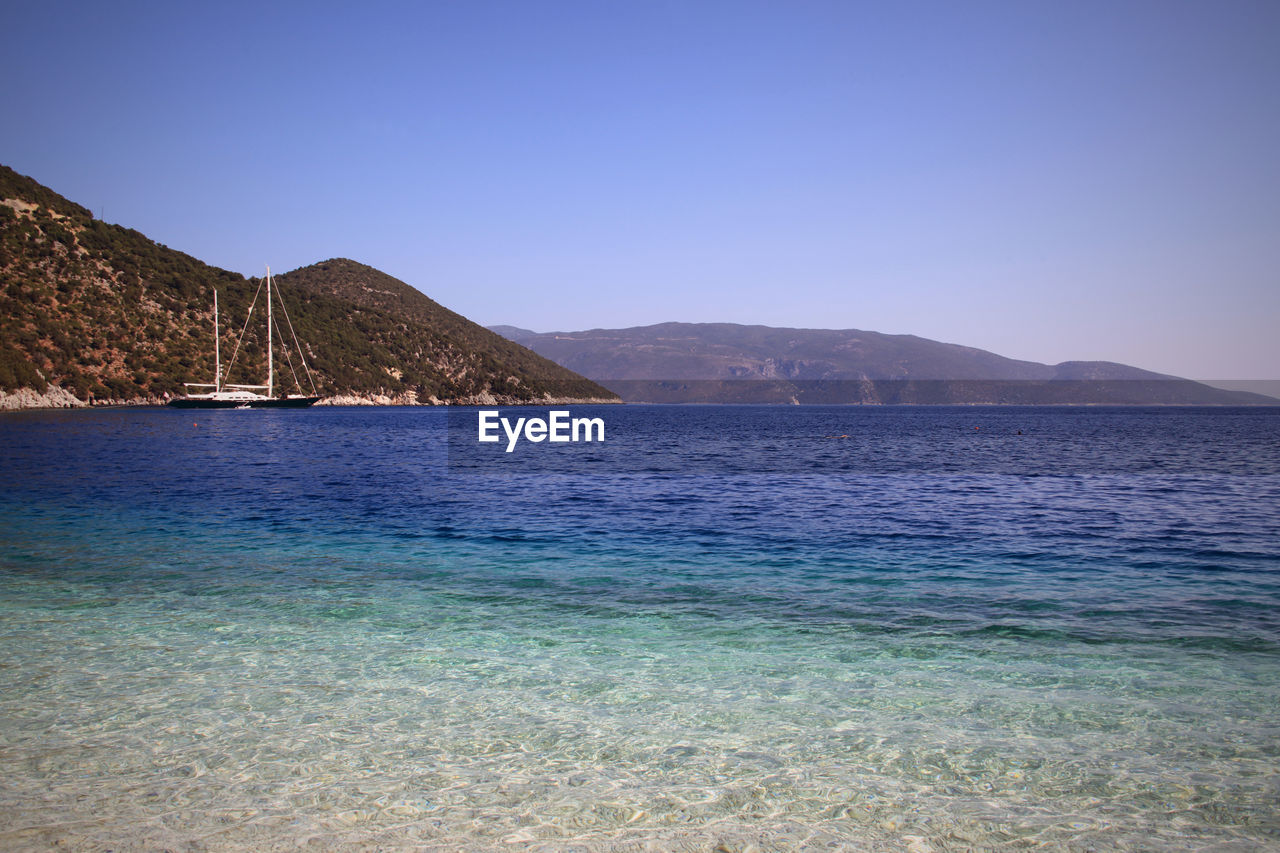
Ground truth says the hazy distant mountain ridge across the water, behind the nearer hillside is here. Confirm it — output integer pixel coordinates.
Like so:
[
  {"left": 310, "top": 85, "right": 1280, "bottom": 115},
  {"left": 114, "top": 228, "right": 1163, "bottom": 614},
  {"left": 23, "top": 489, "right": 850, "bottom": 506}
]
[{"left": 490, "top": 323, "right": 1280, "bottom": 405}]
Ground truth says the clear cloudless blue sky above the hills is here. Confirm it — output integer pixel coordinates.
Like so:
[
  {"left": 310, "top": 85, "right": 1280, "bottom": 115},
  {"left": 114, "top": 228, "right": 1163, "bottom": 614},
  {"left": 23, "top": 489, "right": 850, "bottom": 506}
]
[{"left": 0, "top": 0, "right": 1280, "bottom": 379}]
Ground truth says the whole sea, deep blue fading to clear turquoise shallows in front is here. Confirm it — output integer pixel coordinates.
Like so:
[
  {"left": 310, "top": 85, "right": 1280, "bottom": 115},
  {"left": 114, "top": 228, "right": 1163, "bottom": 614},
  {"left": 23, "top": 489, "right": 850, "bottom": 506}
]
[{"left": 0, "top": 405, "right": 1280, "bottom": 853}]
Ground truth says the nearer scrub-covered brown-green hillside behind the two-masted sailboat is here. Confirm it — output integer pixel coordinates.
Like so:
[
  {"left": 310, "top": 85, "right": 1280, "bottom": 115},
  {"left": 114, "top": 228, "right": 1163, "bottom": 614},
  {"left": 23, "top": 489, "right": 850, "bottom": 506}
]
[{"left": 0, "top": 167, "right": 613, "bottom": 402}]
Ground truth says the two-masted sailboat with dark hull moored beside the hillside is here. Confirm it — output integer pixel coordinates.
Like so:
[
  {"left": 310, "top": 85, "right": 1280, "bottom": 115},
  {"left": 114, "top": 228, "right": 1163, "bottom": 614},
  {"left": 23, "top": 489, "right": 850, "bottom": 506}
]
[{"left": 169, "top": 266, "right": 320, "bottom": 409}]
